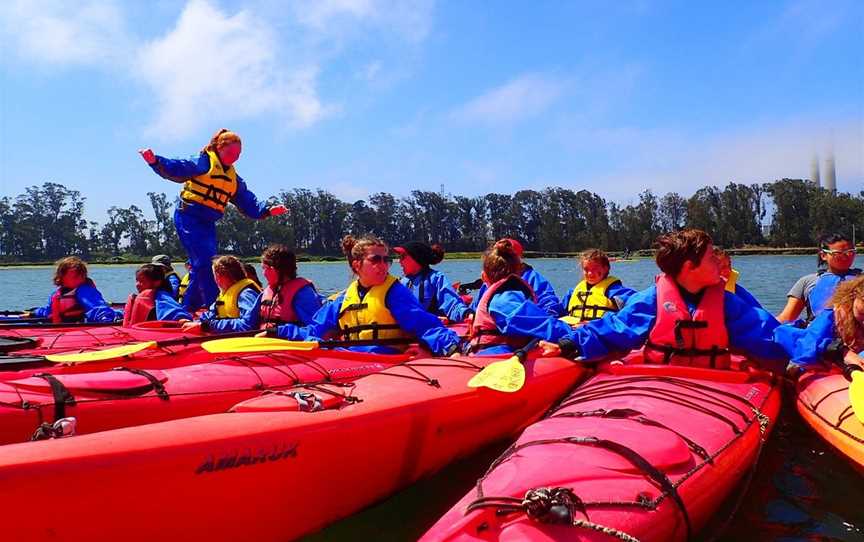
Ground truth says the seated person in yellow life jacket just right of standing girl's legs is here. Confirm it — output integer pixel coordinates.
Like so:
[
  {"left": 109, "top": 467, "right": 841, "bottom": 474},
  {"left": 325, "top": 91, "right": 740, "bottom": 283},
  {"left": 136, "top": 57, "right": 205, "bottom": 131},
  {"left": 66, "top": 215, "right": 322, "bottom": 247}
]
[{"left": 182, "top": 256, "right": 261, "bottom": 333}]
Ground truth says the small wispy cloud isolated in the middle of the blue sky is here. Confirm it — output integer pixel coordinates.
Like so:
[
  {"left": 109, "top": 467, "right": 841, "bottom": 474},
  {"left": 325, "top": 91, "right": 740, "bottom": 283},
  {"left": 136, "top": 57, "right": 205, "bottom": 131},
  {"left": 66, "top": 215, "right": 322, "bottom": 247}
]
[{"left": 450, "top": 74, "right": 565, "bottom": 124}]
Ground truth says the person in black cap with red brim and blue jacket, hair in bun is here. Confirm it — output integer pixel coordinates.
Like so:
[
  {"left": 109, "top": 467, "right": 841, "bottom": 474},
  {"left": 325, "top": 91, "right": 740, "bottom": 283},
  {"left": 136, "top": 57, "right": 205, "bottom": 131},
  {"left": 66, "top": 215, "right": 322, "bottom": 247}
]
[{"left": 393, "top": 241, "right": 474, "bottom": 322}]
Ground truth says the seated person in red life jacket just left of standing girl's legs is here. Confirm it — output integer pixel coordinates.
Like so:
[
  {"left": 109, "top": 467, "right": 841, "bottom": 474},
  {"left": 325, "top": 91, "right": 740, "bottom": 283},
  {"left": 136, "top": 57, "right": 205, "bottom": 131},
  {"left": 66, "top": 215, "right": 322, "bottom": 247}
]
[{"left": 123, "top": 263, "right": 192, "bottom": 327}]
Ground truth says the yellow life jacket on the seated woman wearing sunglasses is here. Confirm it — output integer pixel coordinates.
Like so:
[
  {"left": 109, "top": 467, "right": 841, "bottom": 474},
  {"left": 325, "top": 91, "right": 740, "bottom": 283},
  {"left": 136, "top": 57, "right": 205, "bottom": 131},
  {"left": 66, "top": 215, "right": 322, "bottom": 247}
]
[{"left": 339, "top": 275, "right": 412, "bottom": 346}]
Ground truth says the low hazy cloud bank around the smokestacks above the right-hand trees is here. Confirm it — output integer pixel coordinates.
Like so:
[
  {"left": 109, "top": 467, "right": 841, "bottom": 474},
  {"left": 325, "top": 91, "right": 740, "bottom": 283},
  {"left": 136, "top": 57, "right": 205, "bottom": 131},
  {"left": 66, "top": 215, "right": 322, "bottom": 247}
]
[{"left": 560, "top": 119, "right": 864, "bottom": 201}]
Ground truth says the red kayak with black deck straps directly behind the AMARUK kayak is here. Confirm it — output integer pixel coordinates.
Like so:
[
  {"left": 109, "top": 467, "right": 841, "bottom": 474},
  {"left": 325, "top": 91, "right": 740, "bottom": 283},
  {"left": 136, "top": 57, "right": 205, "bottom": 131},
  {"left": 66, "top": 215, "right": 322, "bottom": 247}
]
[{"left": 0, "top": 349, "right": 408, "bottom": 444}]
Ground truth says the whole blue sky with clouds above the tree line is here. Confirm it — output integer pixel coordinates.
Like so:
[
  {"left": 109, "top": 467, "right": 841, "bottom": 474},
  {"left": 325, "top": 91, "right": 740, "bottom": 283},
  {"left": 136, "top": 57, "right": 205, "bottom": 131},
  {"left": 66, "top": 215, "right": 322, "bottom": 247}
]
[{"left": 0, "top": 0, "right": 864, "bottom": 220}]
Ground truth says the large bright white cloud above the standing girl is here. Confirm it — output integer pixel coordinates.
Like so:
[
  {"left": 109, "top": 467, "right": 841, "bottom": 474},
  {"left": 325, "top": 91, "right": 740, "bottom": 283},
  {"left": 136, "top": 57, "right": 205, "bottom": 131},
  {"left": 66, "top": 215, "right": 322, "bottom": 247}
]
[{"left": 134, "top": 0, "right": 327, "bottom": 138}]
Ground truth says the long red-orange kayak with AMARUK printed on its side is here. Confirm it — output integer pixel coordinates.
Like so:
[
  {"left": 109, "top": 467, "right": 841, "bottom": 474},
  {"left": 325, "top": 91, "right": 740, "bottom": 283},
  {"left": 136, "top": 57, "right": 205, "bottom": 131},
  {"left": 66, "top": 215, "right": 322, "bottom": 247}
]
[{"left": 0, "top": 350, "right": 584, "bottom": 542}]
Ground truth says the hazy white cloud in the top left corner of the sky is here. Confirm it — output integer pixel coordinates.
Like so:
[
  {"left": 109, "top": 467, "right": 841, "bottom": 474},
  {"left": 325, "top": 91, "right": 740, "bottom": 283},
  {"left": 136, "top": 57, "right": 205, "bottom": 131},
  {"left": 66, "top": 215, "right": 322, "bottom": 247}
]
[{"left": 0, "top": 0, "right": 130, "bottom": 67}]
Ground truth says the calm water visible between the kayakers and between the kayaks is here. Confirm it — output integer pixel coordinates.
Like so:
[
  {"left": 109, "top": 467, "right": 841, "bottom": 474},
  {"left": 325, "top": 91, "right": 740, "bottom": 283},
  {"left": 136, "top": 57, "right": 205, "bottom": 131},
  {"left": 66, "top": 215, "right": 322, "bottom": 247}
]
[{"left": 0, "top": 256, "right": 864, "bottom": 541}]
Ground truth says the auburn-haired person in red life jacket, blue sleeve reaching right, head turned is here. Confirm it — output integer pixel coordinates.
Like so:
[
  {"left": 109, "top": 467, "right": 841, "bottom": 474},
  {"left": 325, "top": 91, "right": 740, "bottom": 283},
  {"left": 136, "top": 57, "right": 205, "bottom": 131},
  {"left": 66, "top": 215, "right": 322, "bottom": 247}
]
[{"left": 468, "top": 239, "right": 571, "bottom": 355}]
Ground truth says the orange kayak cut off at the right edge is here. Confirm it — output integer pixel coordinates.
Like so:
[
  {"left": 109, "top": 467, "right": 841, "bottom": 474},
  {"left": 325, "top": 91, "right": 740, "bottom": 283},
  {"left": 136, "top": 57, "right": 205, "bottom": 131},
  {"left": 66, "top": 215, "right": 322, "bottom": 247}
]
[{"left": 796, "top": 371, "right": 864, "bottom": 473}]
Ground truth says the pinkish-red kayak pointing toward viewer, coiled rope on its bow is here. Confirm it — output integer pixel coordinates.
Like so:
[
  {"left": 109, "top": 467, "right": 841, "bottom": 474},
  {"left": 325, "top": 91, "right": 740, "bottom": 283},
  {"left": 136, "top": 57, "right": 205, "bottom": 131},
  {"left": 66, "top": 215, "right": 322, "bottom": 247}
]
[{"left": 423, "top": 360, "right": 780, "bottom": 542}]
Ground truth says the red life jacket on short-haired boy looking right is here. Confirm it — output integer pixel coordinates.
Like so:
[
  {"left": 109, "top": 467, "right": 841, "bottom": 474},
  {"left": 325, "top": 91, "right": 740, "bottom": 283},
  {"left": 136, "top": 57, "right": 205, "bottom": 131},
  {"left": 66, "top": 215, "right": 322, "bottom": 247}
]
[{"left": 642, "top": 274, "right": 730, "bottom": 369}]
